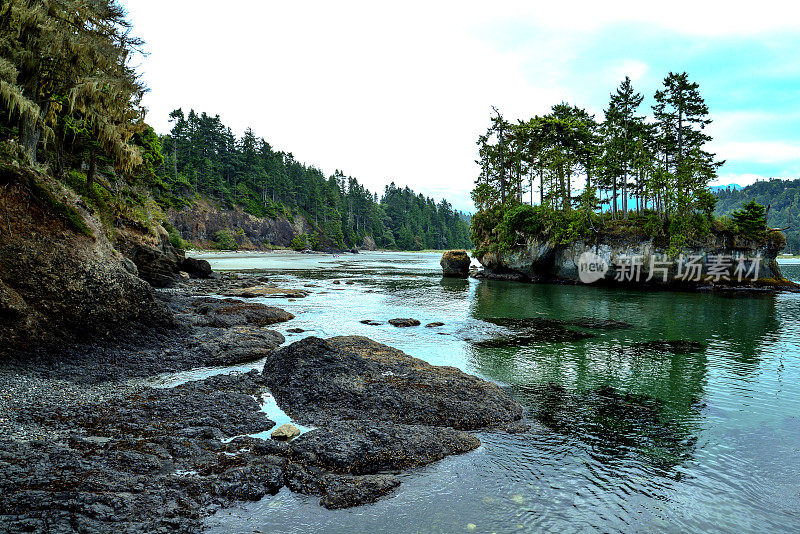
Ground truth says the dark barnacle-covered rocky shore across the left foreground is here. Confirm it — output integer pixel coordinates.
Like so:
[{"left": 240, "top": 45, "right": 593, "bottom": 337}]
[{"left": 0, "top": 275, "right": 526, "bottom": 532}]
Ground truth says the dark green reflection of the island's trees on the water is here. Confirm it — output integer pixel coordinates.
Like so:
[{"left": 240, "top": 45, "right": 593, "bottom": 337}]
[{"left": 470, "top": 281, "right": 780, "bottom": 478}]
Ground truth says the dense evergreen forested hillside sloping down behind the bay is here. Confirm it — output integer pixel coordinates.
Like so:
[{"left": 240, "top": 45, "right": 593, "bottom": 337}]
[{"left": 153, "top": 109, "right": 470, "bottom": 250}]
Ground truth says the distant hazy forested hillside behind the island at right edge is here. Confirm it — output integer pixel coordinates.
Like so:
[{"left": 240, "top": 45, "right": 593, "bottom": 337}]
[{"left": 715, "top": 179, "right": 800, "bottom": 254}]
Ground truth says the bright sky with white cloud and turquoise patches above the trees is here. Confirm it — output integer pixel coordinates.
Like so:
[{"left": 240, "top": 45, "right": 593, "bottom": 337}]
[{"left": 122, "top": 0, "right": 800, "bottom": 211}]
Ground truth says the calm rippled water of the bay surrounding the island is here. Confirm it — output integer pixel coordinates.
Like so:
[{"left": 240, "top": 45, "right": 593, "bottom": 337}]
[{"left": 192, "top": 253, "right": 800, "bottom": 533}]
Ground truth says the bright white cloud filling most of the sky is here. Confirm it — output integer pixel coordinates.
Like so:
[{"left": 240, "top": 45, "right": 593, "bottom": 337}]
[{"left": 126, "top": 0, "right": 800, "bottom": 214}]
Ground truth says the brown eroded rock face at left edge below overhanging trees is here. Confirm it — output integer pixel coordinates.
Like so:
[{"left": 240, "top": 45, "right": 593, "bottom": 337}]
[{"left": 0, "top": 169, "right": 169, "bottom": 357}]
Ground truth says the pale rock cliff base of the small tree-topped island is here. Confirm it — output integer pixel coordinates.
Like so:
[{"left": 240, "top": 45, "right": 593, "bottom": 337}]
[{"left": 478, "top": 232, "right": 796, "bottom": 289}]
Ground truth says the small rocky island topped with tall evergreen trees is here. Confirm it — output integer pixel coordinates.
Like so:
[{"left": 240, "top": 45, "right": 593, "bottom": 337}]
[{"left": 472, "top": 72, "right": 791, "bottom": 288}]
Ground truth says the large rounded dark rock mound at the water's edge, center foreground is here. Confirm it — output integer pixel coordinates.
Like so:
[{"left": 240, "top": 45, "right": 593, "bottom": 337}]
[{"left": 263, "top": 336, "right": 522, "bottom": 430}]
